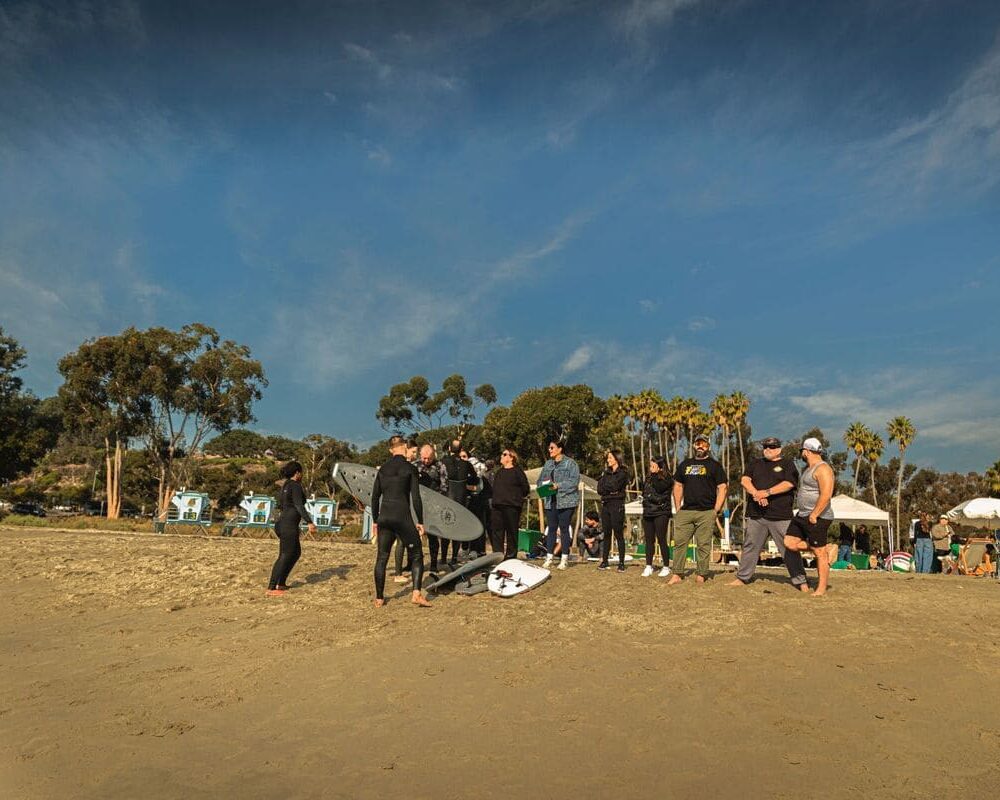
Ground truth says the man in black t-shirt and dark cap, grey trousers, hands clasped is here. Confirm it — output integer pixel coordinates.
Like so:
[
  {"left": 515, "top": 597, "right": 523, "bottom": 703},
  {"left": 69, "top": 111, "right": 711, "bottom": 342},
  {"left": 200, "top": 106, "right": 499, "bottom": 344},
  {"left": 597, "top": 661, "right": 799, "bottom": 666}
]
[{"left": 729, "top": 436, "right": 809, "bottom": 592}]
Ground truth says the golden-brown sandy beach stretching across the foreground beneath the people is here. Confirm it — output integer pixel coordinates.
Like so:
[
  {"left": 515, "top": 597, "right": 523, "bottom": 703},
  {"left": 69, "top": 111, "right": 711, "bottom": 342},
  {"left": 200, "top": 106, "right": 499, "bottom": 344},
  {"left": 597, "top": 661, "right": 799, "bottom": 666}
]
[{"left": 0, "top": 529, "right": 1000, "bottom": 800}]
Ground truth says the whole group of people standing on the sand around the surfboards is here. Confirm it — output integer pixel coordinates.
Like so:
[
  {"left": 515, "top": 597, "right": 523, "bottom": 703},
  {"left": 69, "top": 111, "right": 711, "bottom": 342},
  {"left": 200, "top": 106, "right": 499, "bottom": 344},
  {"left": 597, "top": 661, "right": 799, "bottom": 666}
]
[{"left": 268, "top": 435, "right": 852, "bottom": 607}]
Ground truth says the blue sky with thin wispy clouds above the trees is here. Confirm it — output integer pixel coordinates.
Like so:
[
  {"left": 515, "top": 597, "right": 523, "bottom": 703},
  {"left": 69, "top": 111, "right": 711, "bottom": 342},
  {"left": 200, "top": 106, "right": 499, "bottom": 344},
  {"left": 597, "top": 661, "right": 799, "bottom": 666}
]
[{"left": 0, "top": 0, "right": 1000, "bottom": 470}]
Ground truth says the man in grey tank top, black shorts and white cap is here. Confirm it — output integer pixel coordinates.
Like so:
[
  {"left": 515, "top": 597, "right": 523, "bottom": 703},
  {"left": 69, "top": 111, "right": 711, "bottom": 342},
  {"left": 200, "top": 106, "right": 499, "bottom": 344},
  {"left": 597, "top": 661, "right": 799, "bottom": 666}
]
[{"left": 785, "top": 437, "right": 834, "bottom": 597}]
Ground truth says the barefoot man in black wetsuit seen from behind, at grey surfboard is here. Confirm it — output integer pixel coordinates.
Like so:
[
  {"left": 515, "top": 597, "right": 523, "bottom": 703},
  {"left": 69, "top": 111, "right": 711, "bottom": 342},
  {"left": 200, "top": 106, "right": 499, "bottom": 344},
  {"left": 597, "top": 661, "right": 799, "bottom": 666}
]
[{"left": 371, "top": 436, "right": 430, "bottom": 608}]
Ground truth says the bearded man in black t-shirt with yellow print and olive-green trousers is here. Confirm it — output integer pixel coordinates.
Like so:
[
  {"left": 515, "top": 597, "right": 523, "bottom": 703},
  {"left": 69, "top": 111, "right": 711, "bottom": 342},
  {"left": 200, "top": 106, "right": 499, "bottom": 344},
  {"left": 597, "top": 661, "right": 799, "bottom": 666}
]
[{"left": 667, "top": 434, "right": 729, "bottom": 586}]
